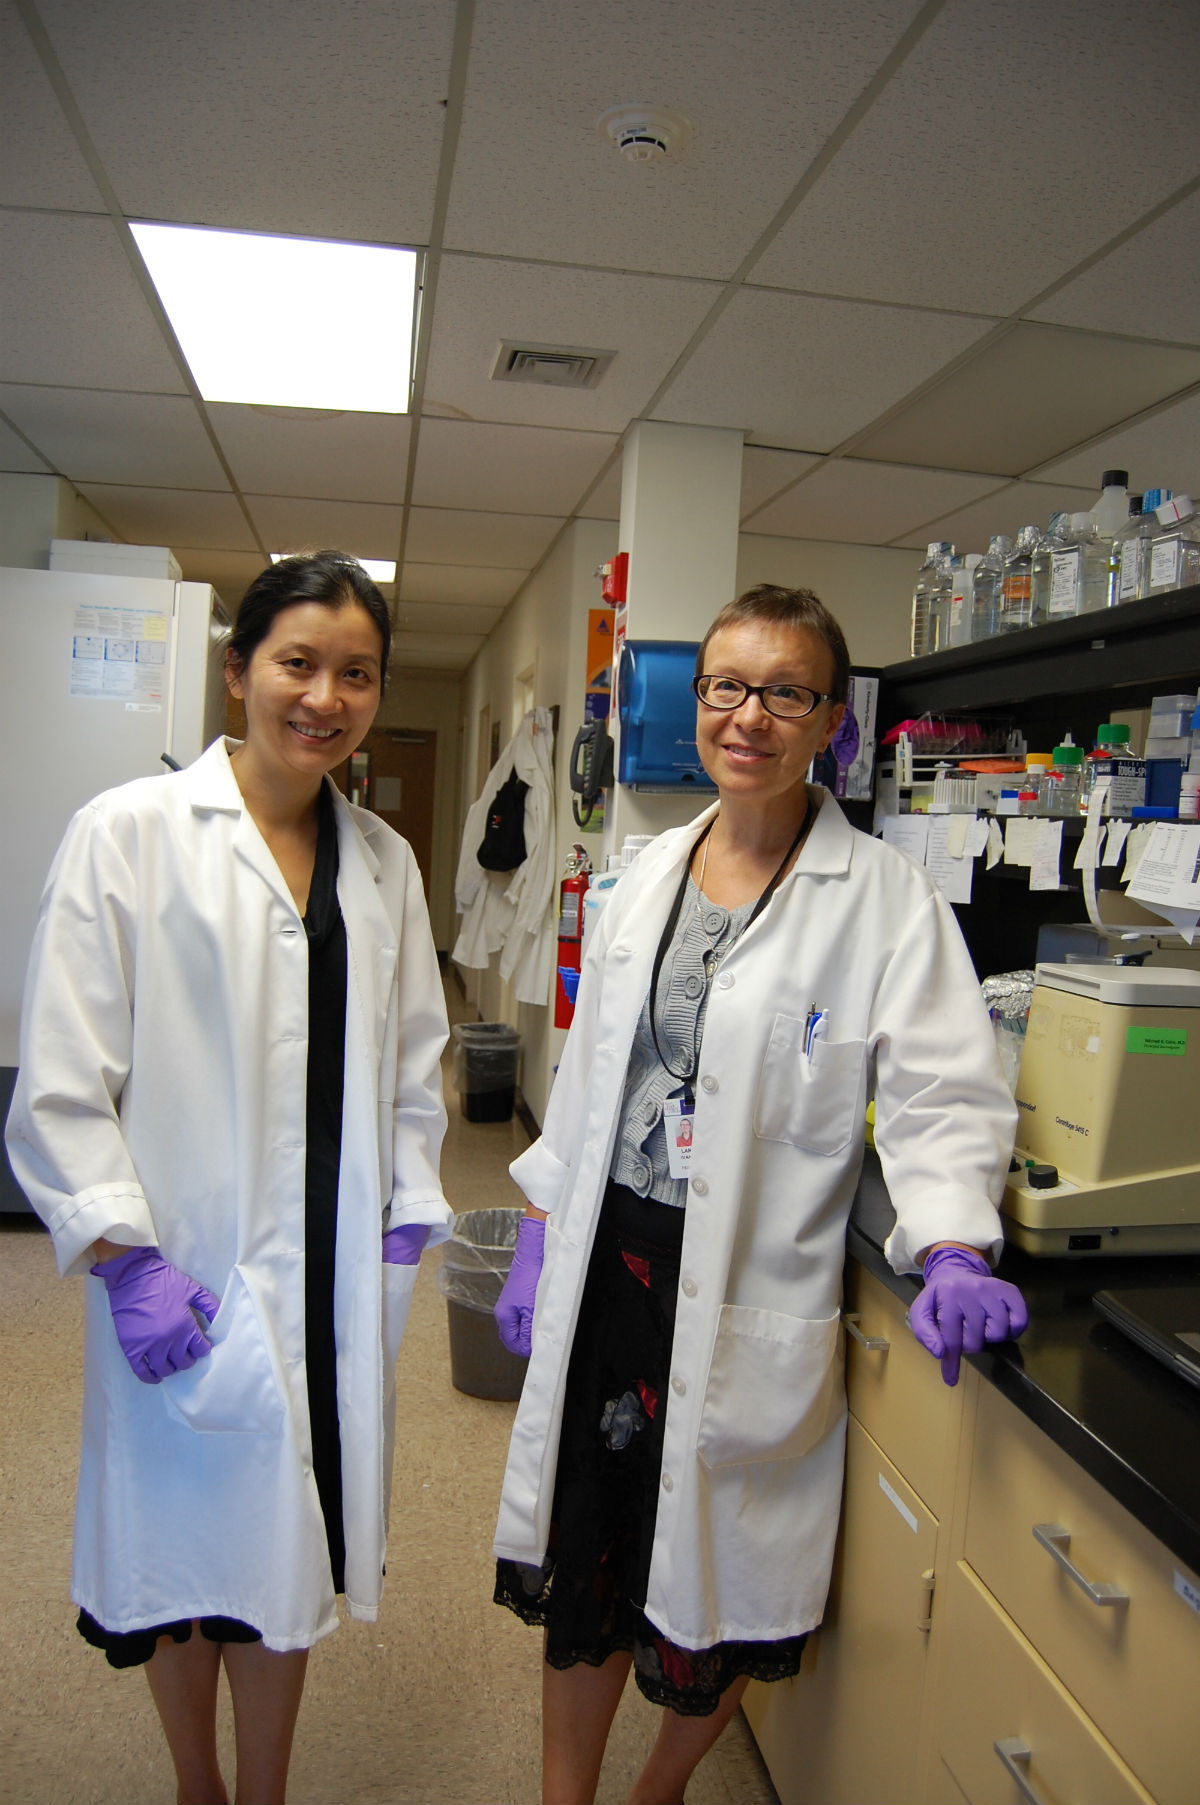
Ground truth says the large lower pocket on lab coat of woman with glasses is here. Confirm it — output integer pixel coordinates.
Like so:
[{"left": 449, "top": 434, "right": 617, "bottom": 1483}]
[{"left": 697, "top": 1303, "right": 843, "bottom": 1467}]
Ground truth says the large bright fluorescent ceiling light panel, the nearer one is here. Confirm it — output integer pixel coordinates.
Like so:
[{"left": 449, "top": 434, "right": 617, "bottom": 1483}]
[{"left": 130, "top": 226, "right": 417, "bottom": 413}]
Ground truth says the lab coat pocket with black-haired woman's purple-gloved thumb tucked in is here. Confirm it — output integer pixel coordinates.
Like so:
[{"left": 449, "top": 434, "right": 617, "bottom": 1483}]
[{"left": 162, "top": 1265, "right": 283, "bottom": 1435}]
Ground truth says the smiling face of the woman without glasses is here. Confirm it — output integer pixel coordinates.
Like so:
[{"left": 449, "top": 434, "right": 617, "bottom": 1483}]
[{"left": 226, "top": 601, "right": 383, "bottom": 780}]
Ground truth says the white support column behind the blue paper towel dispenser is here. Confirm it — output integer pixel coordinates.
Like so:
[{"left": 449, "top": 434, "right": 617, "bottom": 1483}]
[{"left": 605, "top": 421, "right": 742, "bottom": 850}]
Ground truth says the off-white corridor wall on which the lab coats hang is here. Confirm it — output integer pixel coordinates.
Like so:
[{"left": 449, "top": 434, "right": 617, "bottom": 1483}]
[{"left": 457, "top": 520, "right": 617, "bottom": 1121}]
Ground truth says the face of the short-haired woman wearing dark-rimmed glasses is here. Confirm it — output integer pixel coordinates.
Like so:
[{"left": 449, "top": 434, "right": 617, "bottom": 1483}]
[{"left": 697, "top": 621, "right": 846, "bottom": 803}]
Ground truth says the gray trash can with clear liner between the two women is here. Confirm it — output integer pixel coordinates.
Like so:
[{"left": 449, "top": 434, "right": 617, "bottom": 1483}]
[{"left": 438, "top": 1209, "right": 529, "bottom": 1401}]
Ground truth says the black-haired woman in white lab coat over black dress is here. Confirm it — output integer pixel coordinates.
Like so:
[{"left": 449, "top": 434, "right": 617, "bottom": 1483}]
[{"left": 7, "top": 552, "right": 449, "bottom": 1805}]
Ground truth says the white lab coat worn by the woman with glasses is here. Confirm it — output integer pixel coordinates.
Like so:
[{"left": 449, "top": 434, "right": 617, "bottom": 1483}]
[{"left": 496, "top": 791, "right": 1016, "bottom": 1648}]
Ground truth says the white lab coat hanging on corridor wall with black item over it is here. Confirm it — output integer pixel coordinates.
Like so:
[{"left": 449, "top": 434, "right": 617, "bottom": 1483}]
[{"left": 451, "top": 708, "right": 558, "bottom": 1005}]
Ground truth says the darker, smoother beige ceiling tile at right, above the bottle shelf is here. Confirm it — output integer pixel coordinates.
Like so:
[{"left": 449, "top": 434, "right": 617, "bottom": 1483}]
[{"left": 855, "top": 325, "right": 1200, "bottom": 477}]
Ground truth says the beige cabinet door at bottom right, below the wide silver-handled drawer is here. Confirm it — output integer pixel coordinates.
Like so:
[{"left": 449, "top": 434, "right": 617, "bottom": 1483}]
[{"left": 938, "top": 1561, "right": 1153, "bottom": 1805}]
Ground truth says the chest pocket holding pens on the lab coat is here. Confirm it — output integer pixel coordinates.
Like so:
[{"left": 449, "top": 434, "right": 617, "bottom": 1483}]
[{"left": 754, "top": 1016, "right": 866, "bottom": 1153}]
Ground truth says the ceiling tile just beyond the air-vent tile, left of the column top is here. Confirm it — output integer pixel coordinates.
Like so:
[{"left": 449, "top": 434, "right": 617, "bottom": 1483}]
[{"left": 413, "top": 421, "right": 617, "bottom": 514}]
